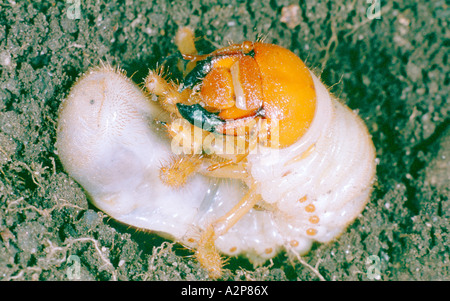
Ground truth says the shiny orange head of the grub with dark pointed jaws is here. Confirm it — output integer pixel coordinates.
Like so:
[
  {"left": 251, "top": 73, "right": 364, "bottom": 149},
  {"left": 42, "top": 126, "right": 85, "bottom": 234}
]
[{"left": 177, "top": 41, "right": 316, "bottom": 148}]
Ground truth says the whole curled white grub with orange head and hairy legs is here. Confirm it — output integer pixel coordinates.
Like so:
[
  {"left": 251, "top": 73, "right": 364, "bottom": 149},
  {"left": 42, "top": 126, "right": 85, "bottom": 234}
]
[{"left": 57, "top": 29, "right": 376, "bottom": 278}]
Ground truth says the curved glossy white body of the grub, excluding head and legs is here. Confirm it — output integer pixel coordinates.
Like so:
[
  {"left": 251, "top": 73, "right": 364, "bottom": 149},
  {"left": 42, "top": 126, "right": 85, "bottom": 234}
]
[{"left": 57, "top": 67, "right": 375, "bottom": 263}]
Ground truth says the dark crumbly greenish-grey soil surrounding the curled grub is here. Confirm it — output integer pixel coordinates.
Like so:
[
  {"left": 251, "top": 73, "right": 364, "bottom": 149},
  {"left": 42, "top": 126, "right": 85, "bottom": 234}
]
[{"left": 0, "top": 0, "right": 450, "bottom": 280}]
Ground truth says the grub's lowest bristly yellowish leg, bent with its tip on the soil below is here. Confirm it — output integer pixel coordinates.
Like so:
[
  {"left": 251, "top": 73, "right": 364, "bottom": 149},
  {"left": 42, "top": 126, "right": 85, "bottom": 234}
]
[{"left": 195, "top": 185, "right": 261, "bottom": 278}]
